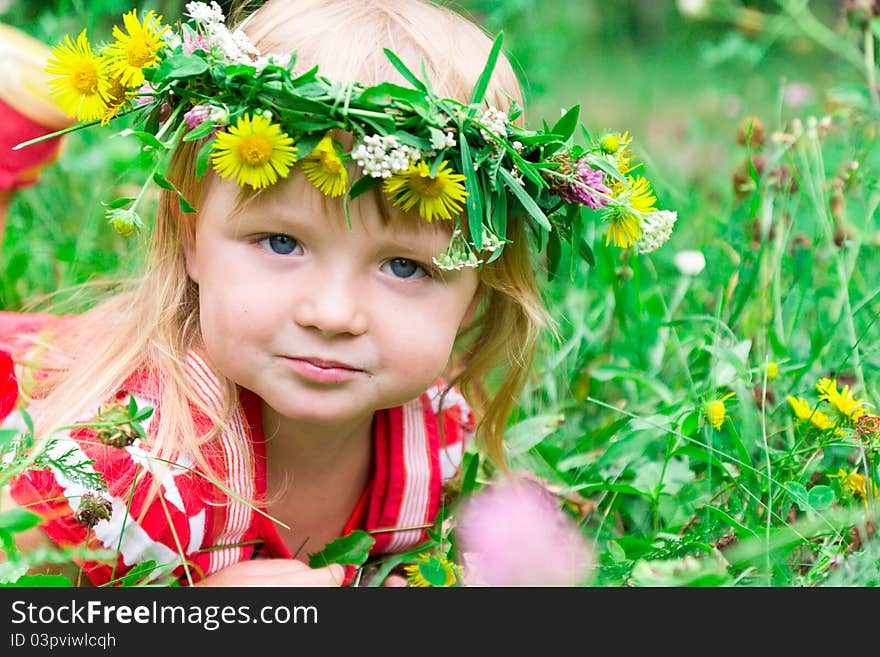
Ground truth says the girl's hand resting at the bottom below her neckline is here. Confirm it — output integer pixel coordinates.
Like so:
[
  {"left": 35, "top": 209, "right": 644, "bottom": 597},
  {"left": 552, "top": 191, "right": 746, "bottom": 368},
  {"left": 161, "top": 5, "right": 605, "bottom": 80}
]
[{"left": 196, "top": 559, "right": 345, "bottom": 586}]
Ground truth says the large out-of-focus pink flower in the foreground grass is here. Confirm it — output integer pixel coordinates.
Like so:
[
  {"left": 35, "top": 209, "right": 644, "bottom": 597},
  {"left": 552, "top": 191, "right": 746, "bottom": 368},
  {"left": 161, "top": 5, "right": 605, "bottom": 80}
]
[{"left": 456, "top": 480, "right": 592, "bottom": 586}]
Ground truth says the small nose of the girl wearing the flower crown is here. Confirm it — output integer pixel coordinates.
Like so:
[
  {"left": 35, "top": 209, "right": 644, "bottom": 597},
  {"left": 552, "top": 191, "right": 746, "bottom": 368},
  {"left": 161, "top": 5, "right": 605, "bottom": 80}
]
[{"left": 293, "top": 272, "right": 369, "bottom": 336}]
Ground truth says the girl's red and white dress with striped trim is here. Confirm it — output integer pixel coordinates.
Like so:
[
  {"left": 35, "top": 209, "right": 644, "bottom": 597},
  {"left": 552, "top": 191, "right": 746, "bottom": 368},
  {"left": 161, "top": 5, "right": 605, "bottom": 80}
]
[{"left": 0, "top": 313, "right": 474, "bottom": 585}]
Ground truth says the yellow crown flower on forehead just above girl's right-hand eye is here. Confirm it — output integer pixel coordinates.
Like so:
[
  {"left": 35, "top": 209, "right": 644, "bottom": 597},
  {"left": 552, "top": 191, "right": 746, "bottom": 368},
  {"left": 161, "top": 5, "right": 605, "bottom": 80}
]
[{"left": 382, "top": 160, "right": 467, "bottom": 221}]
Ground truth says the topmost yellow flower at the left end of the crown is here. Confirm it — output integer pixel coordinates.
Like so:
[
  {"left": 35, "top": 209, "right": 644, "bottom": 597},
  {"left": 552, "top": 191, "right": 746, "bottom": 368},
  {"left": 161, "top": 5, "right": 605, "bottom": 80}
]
[{"left": 104, "top": 9, "right": 170, "bottom": 87}]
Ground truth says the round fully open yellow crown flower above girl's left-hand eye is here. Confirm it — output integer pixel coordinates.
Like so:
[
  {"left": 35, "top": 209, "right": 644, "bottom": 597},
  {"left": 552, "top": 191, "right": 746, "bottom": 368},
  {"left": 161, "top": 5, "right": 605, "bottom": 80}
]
[{"left": 211, "top": 114, "right": 296, "bottom": 189}]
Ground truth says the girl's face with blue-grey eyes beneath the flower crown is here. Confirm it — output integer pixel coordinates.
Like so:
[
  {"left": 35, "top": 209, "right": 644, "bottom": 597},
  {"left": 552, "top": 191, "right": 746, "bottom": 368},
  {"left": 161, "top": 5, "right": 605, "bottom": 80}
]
[{"left": 186, "top": 173, "right": 478, "bottom": 422}]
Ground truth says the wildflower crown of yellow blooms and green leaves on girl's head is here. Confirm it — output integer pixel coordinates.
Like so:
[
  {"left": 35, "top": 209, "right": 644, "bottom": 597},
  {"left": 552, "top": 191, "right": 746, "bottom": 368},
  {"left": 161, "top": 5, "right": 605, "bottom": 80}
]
[{"left": 22, "top": 1, "right": 677, "bottom": 273}]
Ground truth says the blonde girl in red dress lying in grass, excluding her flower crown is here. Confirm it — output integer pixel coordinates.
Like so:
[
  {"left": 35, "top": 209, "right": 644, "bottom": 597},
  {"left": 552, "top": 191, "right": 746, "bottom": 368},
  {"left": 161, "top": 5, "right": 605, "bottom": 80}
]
[{"left": 0, "top": 0, "right": 545, "bottom": 586}]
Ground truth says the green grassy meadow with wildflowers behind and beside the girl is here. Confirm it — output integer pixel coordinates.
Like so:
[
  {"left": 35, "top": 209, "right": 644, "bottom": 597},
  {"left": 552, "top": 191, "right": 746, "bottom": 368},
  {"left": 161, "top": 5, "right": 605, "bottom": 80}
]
[{"left": 0, "top": 0, "right": 880, "bottom": 586}]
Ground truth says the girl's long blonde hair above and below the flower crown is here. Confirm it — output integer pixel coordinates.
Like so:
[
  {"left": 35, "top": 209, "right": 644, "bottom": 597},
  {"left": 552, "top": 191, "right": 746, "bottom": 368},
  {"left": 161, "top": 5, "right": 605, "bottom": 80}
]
[{"left": 15, "top": 0, "right": 546, "bottom": 498}]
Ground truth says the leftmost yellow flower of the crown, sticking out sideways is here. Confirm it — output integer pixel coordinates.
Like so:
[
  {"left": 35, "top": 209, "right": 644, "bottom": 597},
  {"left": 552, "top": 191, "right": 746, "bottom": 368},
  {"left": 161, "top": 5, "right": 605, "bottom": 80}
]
[{"left": 46, "top": 30, "right": 109, "bottom": 121}]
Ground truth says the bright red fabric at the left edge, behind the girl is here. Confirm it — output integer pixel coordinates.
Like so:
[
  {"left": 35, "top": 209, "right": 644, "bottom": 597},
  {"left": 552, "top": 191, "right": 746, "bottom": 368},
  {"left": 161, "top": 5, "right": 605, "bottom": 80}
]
[{"left": 0, "top": 100, "right": 61, "bottom": 191}]
